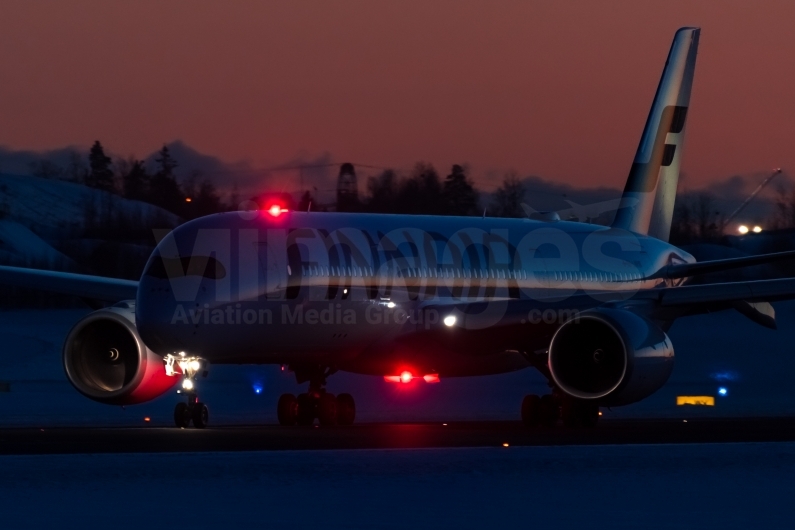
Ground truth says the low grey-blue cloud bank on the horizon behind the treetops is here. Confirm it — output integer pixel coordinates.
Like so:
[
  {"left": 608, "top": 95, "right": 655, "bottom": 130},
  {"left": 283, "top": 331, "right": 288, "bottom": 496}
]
[{"left": 0, "top": 137, "right": 794, "bottom": 224}]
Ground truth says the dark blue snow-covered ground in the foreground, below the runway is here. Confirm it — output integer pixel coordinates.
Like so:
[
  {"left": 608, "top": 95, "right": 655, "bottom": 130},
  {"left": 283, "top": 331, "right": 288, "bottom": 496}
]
[{"left": 0, "top": 444, "right": 795, "bottom": 530}]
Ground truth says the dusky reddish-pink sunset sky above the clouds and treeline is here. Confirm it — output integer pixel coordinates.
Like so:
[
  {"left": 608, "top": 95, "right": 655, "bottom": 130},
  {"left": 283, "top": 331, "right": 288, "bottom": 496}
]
[{"left": 0, "top": 0, "right": 795, "bottom": 192}]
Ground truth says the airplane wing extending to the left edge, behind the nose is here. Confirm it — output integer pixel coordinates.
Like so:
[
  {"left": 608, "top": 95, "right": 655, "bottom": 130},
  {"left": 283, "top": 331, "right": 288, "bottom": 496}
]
[{"left": 0, "top": 266, "right": 138, "bottom": 302}]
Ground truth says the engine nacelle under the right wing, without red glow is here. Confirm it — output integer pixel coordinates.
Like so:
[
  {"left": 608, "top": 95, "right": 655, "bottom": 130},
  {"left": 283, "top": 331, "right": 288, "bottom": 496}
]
[{"left": 549, "top": 308, "right": 674, "bottom": 405}]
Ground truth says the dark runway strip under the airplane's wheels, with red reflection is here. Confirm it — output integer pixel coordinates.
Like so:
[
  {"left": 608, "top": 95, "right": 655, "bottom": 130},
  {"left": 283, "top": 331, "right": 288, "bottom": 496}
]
[{"left": 0, "top": 417, "right": 795, "bottom": 455}]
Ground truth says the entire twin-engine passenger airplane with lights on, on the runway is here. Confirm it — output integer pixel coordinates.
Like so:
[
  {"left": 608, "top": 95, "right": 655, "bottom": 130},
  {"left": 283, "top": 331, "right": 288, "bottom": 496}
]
[{"left": 0, "top": 27, "right": 795, "bottom": 428}]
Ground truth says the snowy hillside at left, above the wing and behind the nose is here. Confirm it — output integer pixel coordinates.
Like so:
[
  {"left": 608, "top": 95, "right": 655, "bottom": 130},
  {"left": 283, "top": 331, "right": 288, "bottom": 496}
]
[{"left": 0, "top": 174, "right": 181, "bottom": 279}]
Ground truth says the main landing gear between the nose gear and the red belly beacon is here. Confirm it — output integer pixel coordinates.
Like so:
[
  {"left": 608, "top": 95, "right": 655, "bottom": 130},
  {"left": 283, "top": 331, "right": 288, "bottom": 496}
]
[{"left": 276, "top": 366, "right": 356, "bottom": 426}]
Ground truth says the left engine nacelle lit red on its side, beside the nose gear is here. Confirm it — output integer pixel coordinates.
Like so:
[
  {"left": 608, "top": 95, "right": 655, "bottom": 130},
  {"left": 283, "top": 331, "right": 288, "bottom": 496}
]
[{"left": 63, "top": 302, "right": 180, "bottom": 405}]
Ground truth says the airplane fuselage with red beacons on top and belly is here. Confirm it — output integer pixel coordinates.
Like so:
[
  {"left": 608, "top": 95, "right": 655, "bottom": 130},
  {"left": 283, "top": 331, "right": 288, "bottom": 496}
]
[{"left": 136, "top": 211, "right": 693, "bottom": 376}]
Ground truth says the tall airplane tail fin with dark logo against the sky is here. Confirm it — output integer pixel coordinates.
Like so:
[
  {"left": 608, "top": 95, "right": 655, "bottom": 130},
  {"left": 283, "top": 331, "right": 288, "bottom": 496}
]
[{"left": 613, "top": 28, "right": 701, "bottom": 237}]
